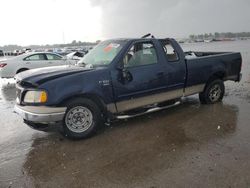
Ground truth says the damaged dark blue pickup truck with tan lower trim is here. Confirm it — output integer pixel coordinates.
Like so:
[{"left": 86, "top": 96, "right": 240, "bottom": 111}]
[{"left": 15, "top": 35, "right": 242, "bottom": 138}]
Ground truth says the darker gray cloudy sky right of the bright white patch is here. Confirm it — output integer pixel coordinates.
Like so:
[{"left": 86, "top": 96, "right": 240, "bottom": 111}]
[{"left": 92, "top": 0, "right": 250, "bottom": 37}]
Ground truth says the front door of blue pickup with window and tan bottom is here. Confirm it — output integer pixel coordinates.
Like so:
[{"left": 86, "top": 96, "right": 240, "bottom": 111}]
[{"left": 111, "top": 40, "right": 170, "bottom": 112}]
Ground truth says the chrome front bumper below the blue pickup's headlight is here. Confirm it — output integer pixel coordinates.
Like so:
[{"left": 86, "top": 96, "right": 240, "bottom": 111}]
[{"left": 14, "top": 105, "right": 66, "bottom": 123}]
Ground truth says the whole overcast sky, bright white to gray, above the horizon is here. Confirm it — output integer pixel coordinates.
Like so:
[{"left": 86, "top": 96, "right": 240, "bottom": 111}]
[{"left": 0, "top": 0, "right": 250, "bottom": 45}]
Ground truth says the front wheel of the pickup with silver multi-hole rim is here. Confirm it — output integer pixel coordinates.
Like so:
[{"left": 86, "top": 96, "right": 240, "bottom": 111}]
[{"left": 63, "top": 98, "right": 102, "bottom": 139}]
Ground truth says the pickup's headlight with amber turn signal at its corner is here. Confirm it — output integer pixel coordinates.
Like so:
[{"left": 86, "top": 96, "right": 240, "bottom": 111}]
[{"left": 24, "top": 91, "right": 48, "bottom": 103}]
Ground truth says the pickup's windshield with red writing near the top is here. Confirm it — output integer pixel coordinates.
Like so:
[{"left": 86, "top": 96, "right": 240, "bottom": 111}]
[{"left": 78, "top": 40, "right": 125, "bottom": 66}]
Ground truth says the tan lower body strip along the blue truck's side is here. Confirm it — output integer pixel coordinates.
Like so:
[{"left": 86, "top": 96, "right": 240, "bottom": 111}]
[{"left": 107, "top": 84, "right": 205, "bottom": 113}]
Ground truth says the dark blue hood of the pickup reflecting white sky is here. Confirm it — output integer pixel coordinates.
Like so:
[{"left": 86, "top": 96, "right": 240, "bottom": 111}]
[{"left": 15, "top": 65, "right": 93, "bottom": 86}]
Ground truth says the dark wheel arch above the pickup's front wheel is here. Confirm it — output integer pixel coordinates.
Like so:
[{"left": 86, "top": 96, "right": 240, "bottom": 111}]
[{"left": 59, "top": 94, "right": 108, "bottom": 116}]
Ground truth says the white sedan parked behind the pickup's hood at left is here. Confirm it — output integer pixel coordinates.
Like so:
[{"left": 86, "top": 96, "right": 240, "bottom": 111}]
[{"left": 0, "top": 52, "right": 76, "bottom": 78}]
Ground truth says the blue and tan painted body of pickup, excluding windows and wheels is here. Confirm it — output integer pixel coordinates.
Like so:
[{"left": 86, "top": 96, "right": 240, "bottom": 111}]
[{"left": 16, "top": 38, "right": 242, "bottom": 122}]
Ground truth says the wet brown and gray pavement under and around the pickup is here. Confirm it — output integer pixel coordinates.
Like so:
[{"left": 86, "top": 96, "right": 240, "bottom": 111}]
[{"left": 0, "top": 41, "right": 250, "bottom": 188}]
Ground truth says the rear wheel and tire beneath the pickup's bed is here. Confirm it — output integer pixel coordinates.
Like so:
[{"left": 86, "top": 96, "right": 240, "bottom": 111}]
[{"left": 199, "top": 79, "right": 225, "bottom": 104}]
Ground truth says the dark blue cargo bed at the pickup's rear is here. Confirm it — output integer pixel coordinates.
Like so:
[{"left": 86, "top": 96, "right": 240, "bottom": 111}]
[{"left": 185, "top": 51, "right": 242, "bottom": 87}]
